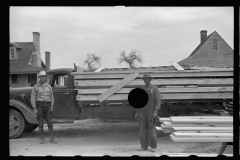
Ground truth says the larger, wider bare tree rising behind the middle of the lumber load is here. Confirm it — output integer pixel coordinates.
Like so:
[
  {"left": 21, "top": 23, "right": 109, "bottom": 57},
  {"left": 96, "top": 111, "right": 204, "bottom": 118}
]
[{"left": 117, "top": 50, "right": 144, "bottom": 68}]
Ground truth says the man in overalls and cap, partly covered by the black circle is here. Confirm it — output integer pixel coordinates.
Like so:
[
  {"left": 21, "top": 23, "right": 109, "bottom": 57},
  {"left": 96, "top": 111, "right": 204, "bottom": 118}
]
[{"left": 135, "top": 74, "right": 161, "bottom": 152}]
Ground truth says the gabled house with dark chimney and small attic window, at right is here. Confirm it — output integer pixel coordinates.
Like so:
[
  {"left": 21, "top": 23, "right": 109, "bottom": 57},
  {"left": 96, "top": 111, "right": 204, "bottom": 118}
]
[{"left": 178, "top": 30, "right": 233, "bottom": 68}]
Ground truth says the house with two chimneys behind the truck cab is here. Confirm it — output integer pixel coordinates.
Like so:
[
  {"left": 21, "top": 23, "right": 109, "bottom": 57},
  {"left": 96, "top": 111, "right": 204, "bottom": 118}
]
[{"left": 9, "top": 32, "right": 50, "bottom": 88}]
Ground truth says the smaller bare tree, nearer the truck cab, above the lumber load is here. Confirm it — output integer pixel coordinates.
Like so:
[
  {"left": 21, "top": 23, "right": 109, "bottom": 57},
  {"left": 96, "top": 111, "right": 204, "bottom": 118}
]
[{"left": 84, "top": 53, "right": 101, "bottom": 71}]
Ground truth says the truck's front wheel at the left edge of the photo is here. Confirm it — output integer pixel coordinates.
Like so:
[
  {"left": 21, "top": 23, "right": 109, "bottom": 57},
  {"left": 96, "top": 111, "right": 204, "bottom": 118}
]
[{"left": 9, "top": 109, "right": 26, "bottom": 139}]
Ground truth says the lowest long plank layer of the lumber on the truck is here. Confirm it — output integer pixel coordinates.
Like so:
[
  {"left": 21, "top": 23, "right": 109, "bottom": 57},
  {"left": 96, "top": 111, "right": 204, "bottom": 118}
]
[{"left": 77, "top": 93, "right": 233, "bottom": 101}]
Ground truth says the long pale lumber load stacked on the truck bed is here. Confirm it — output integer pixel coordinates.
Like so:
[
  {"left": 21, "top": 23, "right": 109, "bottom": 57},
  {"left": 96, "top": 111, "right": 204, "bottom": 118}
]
[{"left": 72, "top": 68, "right": 233, "bottom": 104}]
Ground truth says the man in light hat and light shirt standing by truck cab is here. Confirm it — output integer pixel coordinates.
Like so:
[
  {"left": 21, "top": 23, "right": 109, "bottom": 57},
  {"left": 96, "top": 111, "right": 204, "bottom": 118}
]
[{"left": 31, "top": 71, "right": 57, "bottom": 144}]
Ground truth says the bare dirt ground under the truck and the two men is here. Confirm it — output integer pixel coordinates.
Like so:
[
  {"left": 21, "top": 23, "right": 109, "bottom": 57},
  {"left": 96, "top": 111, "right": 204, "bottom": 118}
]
[{"left": 9, "top": 119, "right": 233, "bottom": 157}]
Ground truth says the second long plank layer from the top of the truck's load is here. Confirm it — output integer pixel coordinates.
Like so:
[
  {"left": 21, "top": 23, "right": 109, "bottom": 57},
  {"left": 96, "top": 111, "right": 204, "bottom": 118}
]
[{"left": 74, "top": 78, "right": 233, "bottom": 88}]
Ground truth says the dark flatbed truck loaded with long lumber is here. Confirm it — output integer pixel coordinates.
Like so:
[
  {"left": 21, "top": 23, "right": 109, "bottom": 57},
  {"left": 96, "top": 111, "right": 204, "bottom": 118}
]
[{"left": 9, "top": 66, "right": 233, "bottom": 139}]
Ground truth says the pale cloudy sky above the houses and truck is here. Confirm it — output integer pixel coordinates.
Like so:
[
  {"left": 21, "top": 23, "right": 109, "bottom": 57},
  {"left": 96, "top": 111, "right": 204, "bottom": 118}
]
[{"left": 9, "top": 6, "right": 234, "bottom": 69}]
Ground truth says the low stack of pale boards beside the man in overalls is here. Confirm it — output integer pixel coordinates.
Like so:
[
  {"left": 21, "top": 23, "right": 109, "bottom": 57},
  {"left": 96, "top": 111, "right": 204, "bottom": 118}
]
[{"left": 160, "top": 116, "right": 233, "bottom": 142}]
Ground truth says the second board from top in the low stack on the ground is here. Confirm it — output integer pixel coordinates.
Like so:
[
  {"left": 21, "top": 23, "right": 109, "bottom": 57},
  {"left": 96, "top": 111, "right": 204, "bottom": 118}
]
[{"left": 173, "top": 127, "right": 233, "bottom": 131}]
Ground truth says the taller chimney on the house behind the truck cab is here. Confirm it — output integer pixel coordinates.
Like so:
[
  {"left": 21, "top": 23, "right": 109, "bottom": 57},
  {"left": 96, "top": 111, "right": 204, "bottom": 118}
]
[{"left": 32, "top": 32, "right": 41, "bottom": 67}]
